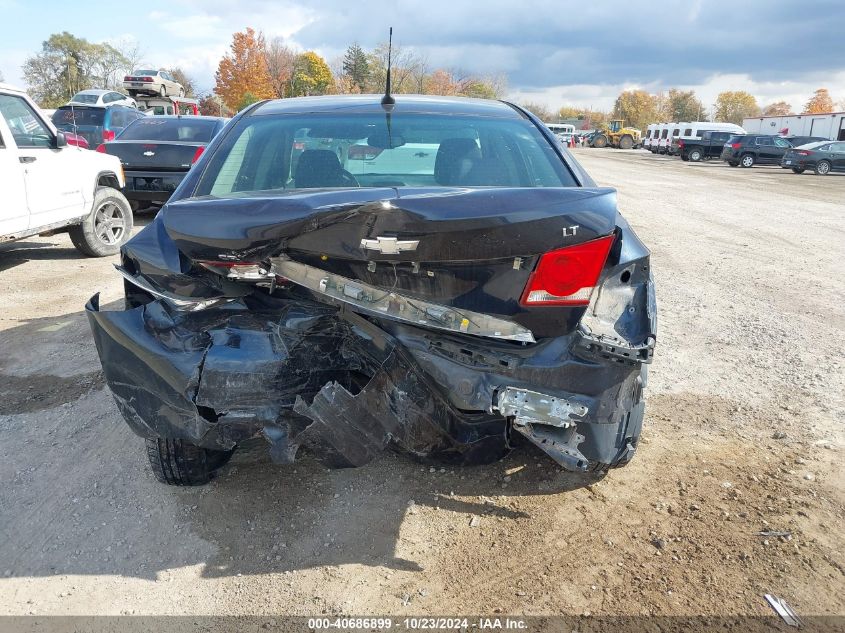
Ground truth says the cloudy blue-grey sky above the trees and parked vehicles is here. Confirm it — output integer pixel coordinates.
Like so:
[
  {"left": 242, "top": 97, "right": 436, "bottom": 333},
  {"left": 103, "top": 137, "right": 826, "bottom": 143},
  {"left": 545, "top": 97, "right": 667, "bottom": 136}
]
[{"left": 0, "top": 0, "right": 845, "bottom": 110}]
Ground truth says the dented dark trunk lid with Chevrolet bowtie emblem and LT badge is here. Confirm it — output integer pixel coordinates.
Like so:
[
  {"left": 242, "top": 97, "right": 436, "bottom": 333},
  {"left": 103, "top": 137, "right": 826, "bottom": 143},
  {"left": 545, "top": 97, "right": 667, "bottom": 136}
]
[{"left": 155, "top": 187, "right": 617, "bottom": 336}]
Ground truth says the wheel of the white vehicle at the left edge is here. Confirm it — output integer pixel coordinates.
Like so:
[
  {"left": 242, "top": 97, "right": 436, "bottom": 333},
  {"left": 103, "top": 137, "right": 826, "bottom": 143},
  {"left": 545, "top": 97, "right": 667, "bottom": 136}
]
[{"left": 68, "top": 187, "right": 132, "bottom": 257}]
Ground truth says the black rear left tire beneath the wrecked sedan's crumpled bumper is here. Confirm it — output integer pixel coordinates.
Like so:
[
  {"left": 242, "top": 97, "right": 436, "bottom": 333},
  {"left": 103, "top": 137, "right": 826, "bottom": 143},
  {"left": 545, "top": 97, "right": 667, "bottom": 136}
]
[{"left": 146, "top": 437, "right": 235, "bottom": 486}]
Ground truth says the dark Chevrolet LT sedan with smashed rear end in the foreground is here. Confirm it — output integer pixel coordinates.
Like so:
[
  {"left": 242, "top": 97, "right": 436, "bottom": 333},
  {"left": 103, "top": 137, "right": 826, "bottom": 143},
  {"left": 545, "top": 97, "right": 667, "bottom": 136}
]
[{"left": 87, "top": 95, "right": 656, "bottom": 485}]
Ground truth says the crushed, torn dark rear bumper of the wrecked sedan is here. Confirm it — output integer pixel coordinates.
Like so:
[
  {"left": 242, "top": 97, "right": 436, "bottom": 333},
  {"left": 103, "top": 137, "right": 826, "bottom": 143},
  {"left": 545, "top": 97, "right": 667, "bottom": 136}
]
[{"left": 86, "top": 286, "right": 653, "bottom": 470}]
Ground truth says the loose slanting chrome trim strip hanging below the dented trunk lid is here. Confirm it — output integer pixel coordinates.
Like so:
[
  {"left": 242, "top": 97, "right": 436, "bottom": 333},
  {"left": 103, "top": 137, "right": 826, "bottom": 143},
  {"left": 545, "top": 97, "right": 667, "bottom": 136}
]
[{"left": 270, "top": 258, "right": 536, "bottom": 343}]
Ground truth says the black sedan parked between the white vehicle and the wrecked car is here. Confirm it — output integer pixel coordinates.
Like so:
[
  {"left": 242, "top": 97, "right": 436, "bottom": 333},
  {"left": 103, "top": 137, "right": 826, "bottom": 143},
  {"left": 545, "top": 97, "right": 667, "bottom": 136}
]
[{"left": 97, "top": 116, "right": 226, "bottom": 209}]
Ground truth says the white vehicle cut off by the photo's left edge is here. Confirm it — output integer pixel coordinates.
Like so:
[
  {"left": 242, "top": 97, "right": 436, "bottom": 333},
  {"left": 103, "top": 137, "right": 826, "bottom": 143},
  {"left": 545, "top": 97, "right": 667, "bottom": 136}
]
[{"left": 0, "top": 83, "right": 132, "bottom": 257}]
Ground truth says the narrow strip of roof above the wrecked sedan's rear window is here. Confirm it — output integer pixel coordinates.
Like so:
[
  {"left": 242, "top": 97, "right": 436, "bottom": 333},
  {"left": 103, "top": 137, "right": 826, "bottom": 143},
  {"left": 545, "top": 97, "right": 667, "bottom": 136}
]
[{"left": 254, "top": 94, "right": 525, "bottom": 119}]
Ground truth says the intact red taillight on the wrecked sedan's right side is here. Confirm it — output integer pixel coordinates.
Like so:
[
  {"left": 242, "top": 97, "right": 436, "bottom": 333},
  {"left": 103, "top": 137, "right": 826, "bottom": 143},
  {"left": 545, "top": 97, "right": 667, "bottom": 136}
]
[{"left": 519, "top": 235, "right": 614, "bottom": 306}]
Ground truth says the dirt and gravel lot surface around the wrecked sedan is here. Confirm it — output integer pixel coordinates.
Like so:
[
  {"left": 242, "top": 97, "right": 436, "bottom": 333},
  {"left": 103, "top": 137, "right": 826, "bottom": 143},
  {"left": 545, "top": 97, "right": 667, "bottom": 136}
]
[{"left": 0, "top": 149, "right": 845, "bottom": 616}]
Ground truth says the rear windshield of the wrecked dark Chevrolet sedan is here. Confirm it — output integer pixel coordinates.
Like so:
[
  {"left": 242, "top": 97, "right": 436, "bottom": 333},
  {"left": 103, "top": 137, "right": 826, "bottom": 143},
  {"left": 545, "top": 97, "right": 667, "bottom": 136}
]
[{"left": 197, "top": 113, "right": 577, "bottom": 196}]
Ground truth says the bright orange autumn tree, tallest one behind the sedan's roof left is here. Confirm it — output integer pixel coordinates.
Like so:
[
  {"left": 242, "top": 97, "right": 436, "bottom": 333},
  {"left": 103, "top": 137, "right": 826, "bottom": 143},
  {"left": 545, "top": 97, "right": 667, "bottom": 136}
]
[{"left": 214, "top": 28, "right": 276, "bottom": 110}]
